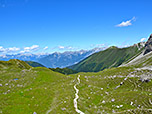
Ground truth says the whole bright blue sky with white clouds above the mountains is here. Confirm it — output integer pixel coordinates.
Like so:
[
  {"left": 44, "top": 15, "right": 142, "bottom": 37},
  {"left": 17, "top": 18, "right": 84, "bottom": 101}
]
[{"left": 0, "top": 0, "right": 152, "bottom": 54}]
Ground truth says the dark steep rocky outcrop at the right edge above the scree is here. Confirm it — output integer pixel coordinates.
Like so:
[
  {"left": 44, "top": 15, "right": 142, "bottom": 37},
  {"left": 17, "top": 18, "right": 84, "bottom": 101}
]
[{"left": 144, "top": 34, "right": 152, "bottom": 55}]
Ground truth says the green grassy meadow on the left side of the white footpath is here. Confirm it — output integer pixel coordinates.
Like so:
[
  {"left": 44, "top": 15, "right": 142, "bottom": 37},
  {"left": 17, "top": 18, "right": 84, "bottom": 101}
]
[{"left": 0, "top": 60, "right": 75, "bottom": 114}]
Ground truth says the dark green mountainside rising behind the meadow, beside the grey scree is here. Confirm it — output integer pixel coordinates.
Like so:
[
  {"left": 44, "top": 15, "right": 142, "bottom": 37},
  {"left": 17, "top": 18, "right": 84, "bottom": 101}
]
[{"left": 69, "top": 46, "right": 142, "bottom": 72}]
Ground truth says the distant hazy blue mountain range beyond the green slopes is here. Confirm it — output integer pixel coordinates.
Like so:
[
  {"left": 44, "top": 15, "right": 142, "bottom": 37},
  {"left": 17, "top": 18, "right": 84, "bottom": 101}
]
[{"left": 0, "top": 47, "right": 105, "bottom": 68}]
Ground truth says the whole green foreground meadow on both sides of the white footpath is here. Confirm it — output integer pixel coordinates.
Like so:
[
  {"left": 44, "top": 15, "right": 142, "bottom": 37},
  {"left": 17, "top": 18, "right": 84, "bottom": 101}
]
[{"left": 0, "top": 60, "right": 152, "bottom": 114}]
